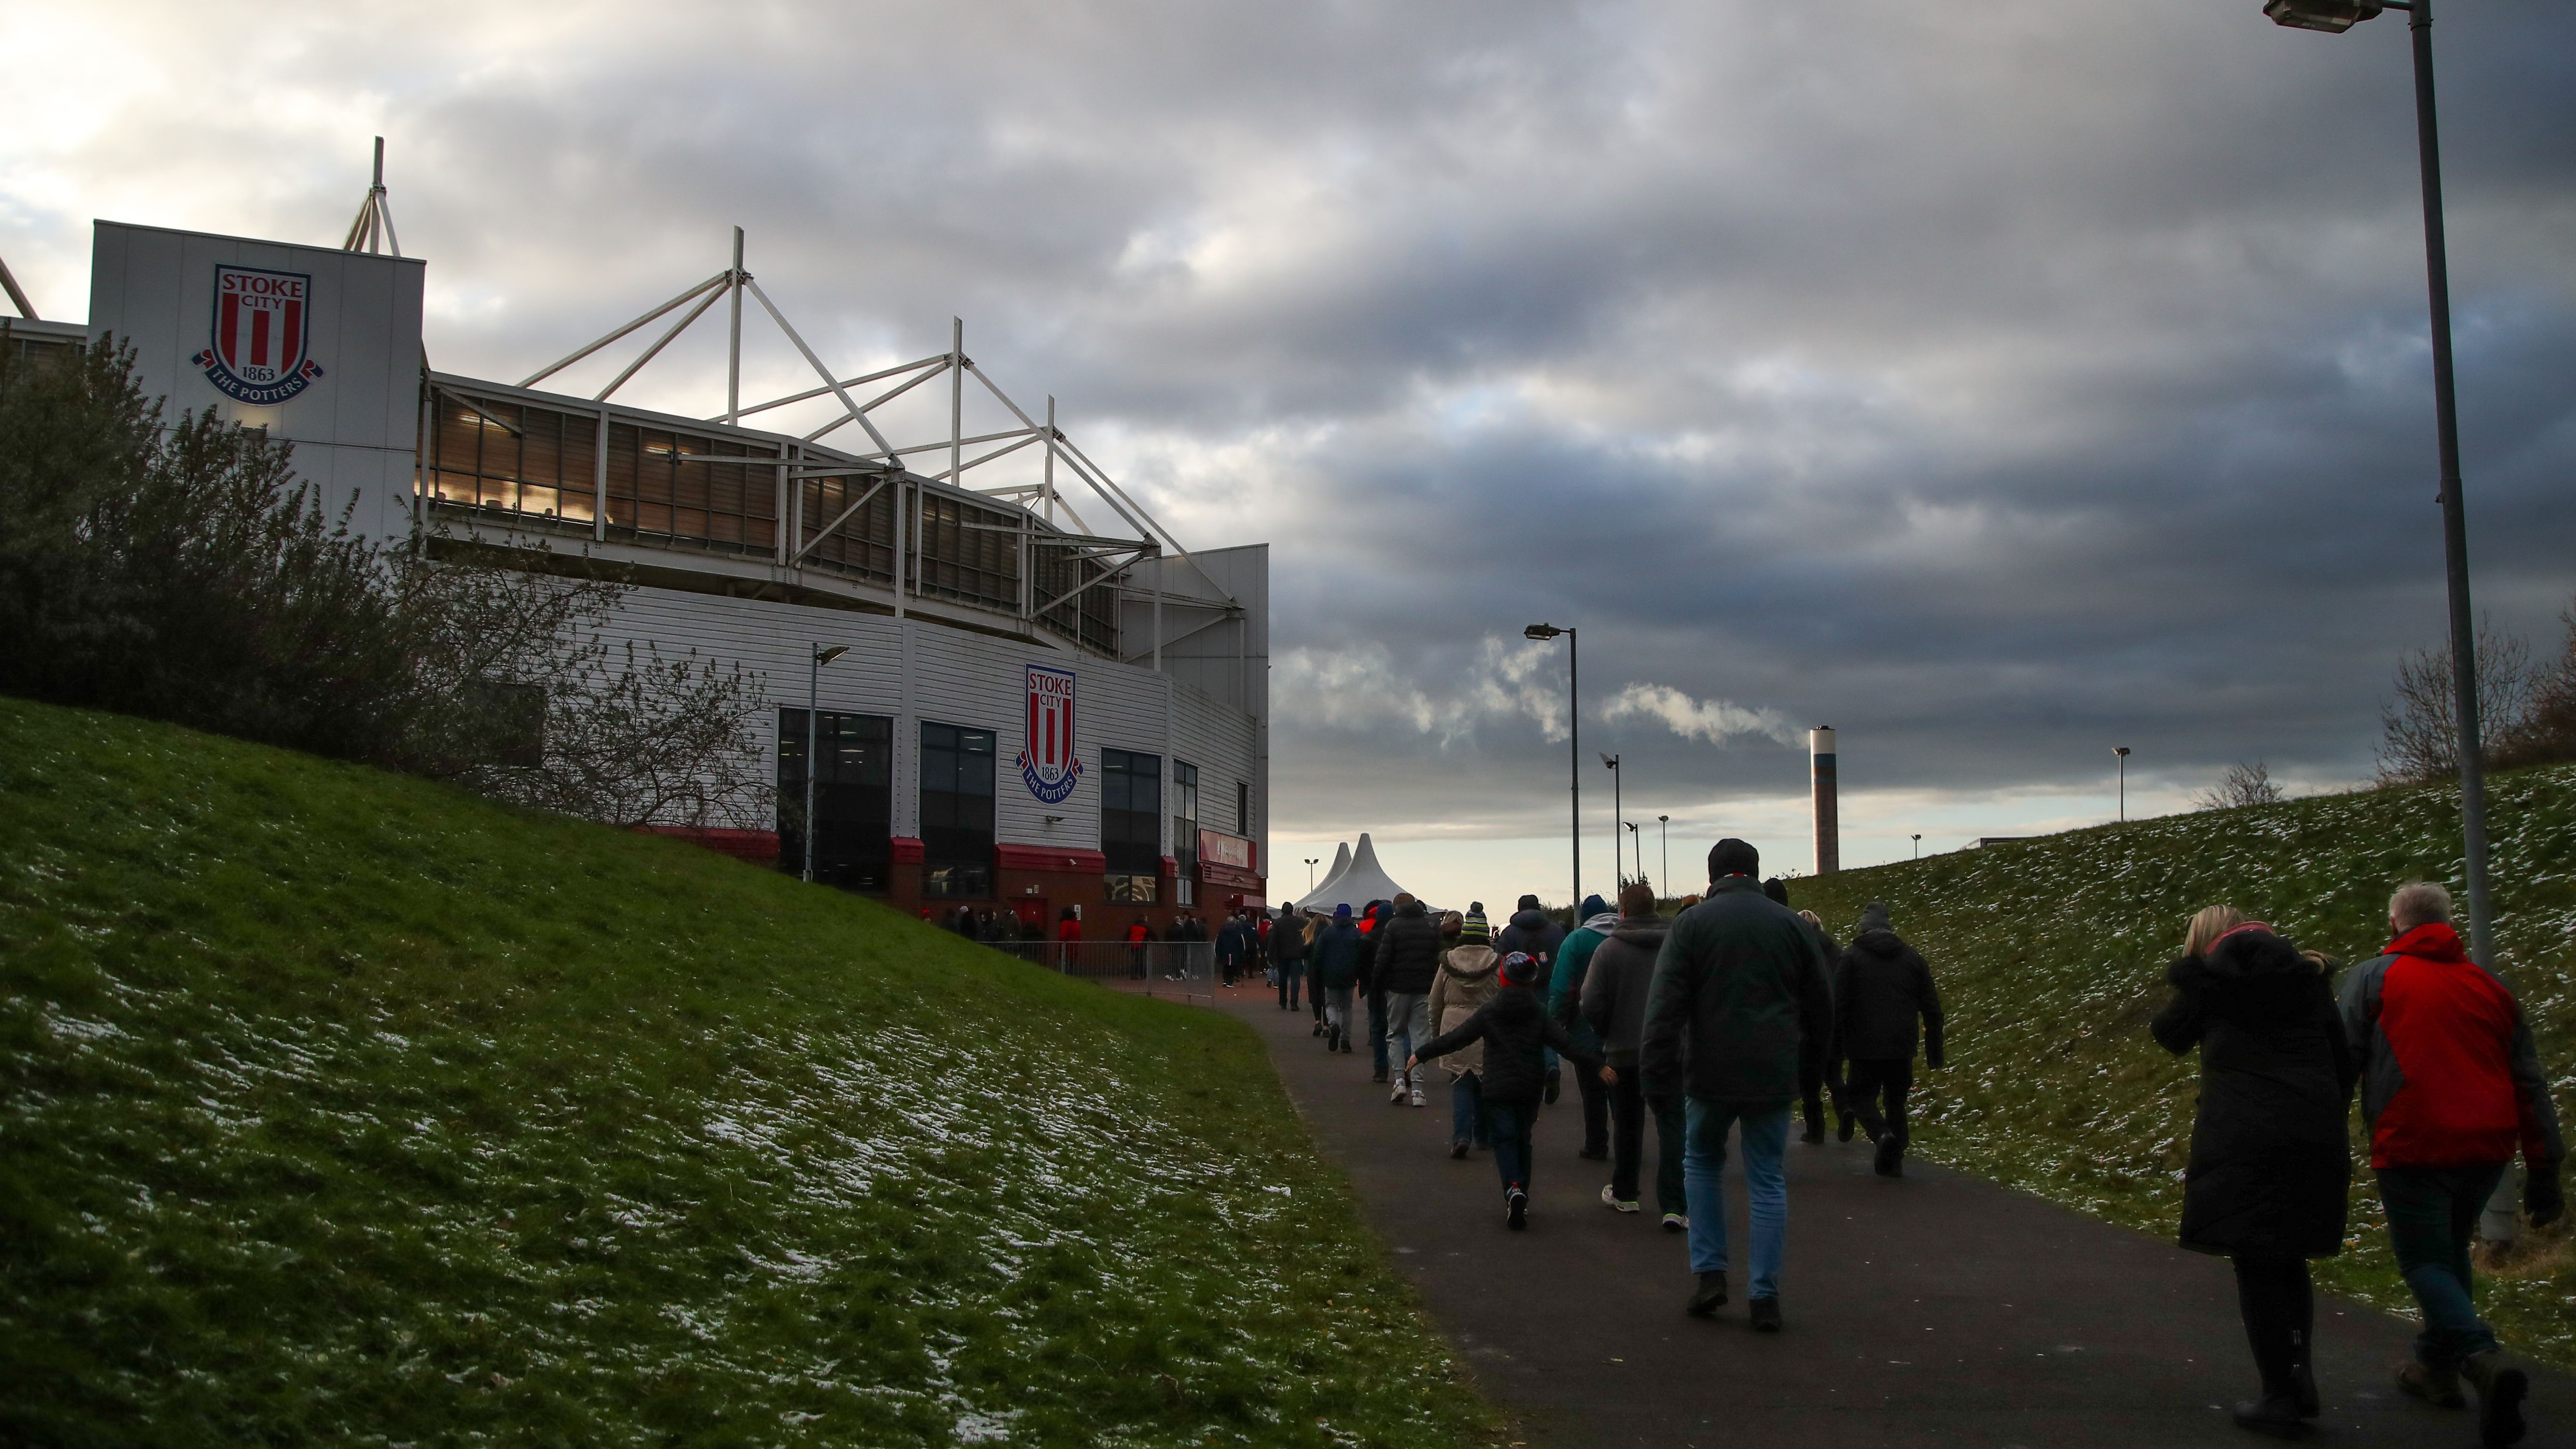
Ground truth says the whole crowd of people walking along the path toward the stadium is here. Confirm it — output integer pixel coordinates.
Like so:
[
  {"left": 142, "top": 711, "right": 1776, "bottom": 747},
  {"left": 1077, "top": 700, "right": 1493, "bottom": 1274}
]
[{"left": 1270, "top": 840, "right": 2566, "bottom": 1447}]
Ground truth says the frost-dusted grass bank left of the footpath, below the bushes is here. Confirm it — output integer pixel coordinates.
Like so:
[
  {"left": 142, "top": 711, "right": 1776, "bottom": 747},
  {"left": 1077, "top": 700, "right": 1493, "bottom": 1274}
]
[{"left": 0, "top": 699, "right": 1491, "bottom": 1449}]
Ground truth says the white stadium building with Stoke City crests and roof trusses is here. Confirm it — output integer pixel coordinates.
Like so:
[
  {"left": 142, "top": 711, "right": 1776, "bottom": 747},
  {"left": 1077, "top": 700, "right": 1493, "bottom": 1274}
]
[{"left": 0, "top": 152, "right": 1270, "bottom": 923}]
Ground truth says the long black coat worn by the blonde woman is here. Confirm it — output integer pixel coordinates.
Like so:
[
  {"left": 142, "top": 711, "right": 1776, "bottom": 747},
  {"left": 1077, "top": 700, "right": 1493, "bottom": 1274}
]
[{"left": 2154, "top": 926, "right": 2357, "bottom": 1258}]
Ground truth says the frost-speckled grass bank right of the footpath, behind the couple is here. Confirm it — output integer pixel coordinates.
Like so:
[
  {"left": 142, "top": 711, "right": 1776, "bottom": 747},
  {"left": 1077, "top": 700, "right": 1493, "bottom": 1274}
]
[{"left": 1790, "top": 766, "right": 2576, "bottom": 1367}]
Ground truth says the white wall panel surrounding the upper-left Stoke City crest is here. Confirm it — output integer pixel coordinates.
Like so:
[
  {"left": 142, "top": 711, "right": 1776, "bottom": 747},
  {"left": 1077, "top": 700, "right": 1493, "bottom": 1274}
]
[{"left": 90, "top": 222, "right": 422, "bottom": 539}]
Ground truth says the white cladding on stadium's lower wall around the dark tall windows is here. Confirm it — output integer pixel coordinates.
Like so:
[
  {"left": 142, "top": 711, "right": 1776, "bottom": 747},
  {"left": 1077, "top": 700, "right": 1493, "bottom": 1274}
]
[{"left": 605, "top": 588, "right": 1267, "bottom": 871}]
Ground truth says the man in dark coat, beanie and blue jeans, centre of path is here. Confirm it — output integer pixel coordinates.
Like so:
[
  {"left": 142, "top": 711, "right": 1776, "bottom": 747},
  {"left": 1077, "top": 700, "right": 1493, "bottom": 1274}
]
[{"left": 1638, "top": 838, "right": 1834, "bottom": 1333}]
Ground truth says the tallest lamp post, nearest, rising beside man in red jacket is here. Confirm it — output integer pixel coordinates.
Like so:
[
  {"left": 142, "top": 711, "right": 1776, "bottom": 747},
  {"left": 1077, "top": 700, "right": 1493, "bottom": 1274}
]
[{"left": 2262, "top": 0, "right": 2494, "bottom": 964}]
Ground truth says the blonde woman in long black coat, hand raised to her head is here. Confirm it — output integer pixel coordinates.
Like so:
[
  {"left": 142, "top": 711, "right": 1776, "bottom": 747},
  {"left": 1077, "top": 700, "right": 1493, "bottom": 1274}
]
[{"left": 2153, "top": 905, "right": 2354, "bottom": 1439}]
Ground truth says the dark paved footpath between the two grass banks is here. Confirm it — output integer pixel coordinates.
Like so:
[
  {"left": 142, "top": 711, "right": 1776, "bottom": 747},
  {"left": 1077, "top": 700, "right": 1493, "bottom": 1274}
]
[{"left": 1218, "top": 977, "right": 2576, "bottom": 1449}]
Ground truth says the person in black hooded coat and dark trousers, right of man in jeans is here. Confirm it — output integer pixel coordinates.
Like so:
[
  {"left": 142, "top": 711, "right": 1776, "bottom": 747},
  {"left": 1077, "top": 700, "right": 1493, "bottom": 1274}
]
[{"left": 1834, "top": 900, "right": 1942, "bottom": 1178}]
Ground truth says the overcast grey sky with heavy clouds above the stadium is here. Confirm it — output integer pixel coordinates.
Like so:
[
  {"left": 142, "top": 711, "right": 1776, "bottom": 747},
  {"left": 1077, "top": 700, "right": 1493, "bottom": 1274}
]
[{"left": 0, "top": 0, "right": 2576, "bottom": 905}]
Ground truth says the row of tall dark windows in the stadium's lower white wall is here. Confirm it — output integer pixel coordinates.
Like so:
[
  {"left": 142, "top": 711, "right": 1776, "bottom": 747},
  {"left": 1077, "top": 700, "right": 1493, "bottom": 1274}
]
[{"left": 778, "top": 709, "right": 1252, "bottom": 905}]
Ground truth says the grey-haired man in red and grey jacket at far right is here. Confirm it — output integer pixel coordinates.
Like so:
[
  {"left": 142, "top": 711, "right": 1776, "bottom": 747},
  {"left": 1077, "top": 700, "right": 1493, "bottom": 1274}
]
[{"left": 2339, "top": 885, "right": 2566, "bottom": 1444}]
